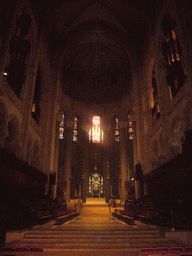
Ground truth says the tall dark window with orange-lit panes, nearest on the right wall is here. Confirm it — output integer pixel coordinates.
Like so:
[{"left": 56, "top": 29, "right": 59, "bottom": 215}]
[{"left": 162, "top": 14, "right": 186, "bottom": 98}]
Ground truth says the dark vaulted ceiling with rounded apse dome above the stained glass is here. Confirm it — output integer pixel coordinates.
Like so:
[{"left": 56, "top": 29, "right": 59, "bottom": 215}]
[{"left": 35, "top": 0, "right": 158, "bottom": 103}]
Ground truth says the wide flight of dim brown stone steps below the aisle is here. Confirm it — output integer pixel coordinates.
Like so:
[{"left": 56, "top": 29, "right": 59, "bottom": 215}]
[{"left": 9, "top": 230, "right": 175, "bottom": 249}]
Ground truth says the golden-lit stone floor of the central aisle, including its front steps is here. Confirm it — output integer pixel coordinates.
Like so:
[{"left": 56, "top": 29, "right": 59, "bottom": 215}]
[{"left": 1, "top": 200, "right": 189, "bottom": 256}]
